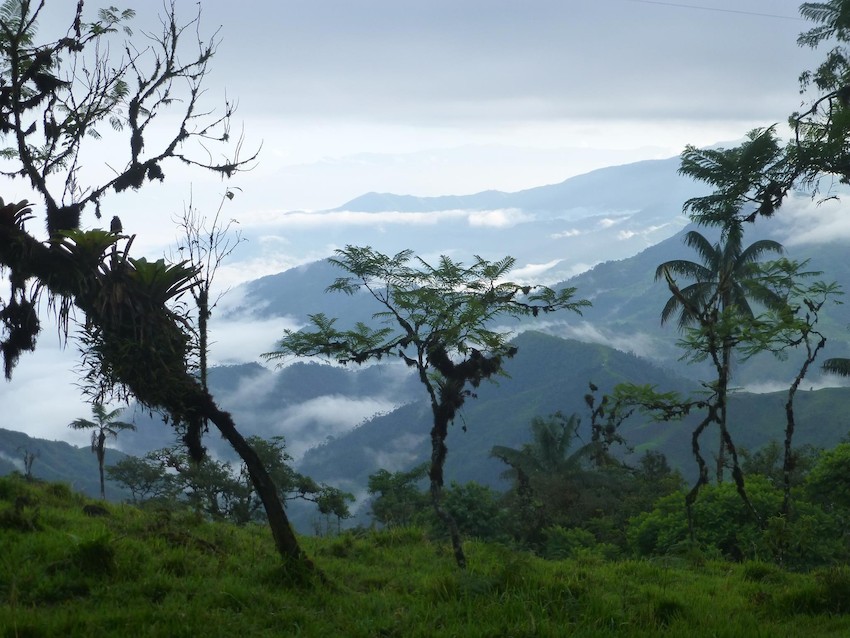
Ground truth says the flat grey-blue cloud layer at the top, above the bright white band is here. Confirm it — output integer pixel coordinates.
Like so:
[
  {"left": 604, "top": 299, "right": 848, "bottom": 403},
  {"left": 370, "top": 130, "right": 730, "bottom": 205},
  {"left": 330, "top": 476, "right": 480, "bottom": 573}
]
[{"left": 195, "top": 0, "right": 817, "bottom": 132}]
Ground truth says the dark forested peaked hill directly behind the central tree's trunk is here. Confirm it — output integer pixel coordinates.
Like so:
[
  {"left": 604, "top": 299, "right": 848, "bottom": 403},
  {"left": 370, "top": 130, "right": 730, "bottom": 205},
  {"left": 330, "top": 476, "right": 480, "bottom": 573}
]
[{"left": 299, "top": 331, "right": 693, "bottom": 496}]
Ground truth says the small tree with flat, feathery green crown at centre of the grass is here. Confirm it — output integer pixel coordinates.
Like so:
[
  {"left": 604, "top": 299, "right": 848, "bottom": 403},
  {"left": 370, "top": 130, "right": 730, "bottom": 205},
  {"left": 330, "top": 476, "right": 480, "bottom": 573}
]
[{"left": 263, "top": 246, "right": 589, "bottom": 567}]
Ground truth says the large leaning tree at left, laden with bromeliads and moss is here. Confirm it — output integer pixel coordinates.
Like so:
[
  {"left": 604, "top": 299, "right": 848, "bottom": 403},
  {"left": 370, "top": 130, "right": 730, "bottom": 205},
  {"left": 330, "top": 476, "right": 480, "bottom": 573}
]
[{"left": 0, "top": 0, "right": 308, "bottom": 564}]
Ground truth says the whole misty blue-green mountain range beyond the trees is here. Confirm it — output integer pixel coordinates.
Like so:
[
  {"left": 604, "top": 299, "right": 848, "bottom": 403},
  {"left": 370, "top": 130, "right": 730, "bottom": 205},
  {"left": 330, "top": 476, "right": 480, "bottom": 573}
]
[{"left": 0, "top": 152, "right": 850, "bottom": 528}]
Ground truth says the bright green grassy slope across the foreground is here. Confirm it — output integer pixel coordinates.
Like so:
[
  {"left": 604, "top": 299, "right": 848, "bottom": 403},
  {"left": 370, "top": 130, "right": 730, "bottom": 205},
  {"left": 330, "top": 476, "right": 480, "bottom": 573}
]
[{"left": 0, "top": 477, "right": 850, "bottom": 638}]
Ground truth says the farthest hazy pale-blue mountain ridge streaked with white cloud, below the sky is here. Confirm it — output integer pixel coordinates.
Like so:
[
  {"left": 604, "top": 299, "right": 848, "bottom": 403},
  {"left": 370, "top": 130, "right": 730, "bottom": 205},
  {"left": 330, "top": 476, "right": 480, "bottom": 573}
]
[{"left": 222, "top": 152, "right": 708, "bottom": 283}]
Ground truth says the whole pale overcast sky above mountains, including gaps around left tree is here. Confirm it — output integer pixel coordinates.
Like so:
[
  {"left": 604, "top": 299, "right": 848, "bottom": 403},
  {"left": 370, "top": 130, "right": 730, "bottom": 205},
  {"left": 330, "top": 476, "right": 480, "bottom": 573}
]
[{"left": 0, "top": 0, "right": 836, "bottom": 444}]
